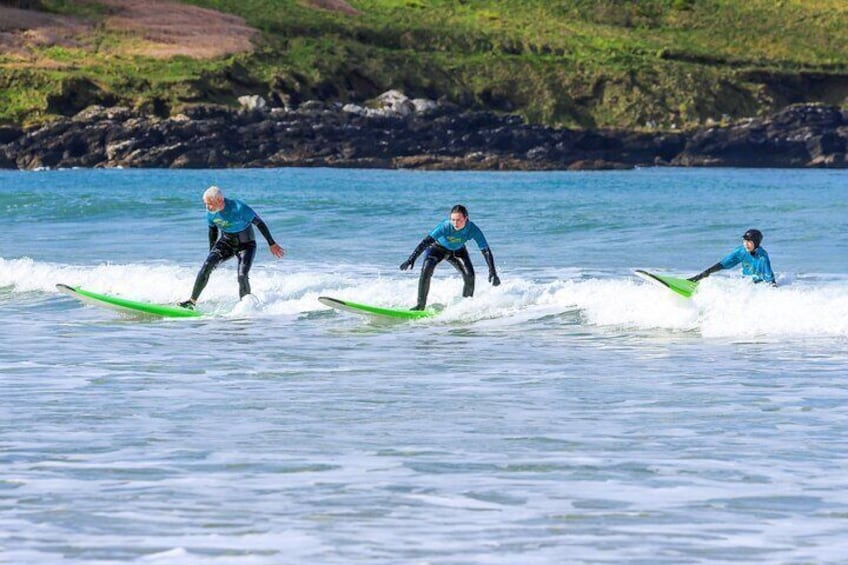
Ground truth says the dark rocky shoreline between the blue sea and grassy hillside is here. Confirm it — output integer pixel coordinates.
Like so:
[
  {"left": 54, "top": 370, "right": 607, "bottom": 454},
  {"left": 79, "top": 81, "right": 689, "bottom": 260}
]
[{"left": 0, "top": 91, "right": 848, "bottom": 170}]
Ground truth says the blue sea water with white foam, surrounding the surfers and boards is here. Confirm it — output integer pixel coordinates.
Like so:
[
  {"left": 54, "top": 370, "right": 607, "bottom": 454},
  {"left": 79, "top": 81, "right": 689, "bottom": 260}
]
[{"left": 0, "top": 165, "right": 848, "bottom": 564}]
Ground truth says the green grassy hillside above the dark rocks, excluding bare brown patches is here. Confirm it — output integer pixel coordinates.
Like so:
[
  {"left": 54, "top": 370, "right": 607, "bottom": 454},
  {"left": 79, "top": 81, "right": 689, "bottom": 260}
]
[{"left": 0, "top": 0, "right": 848, "bottom": 128}]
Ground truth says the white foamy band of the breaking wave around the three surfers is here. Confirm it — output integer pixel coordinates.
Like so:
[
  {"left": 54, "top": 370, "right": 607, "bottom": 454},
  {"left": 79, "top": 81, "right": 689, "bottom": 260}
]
[{"left": 6, "top": 258, "right": 848, "bottom": 338}]
